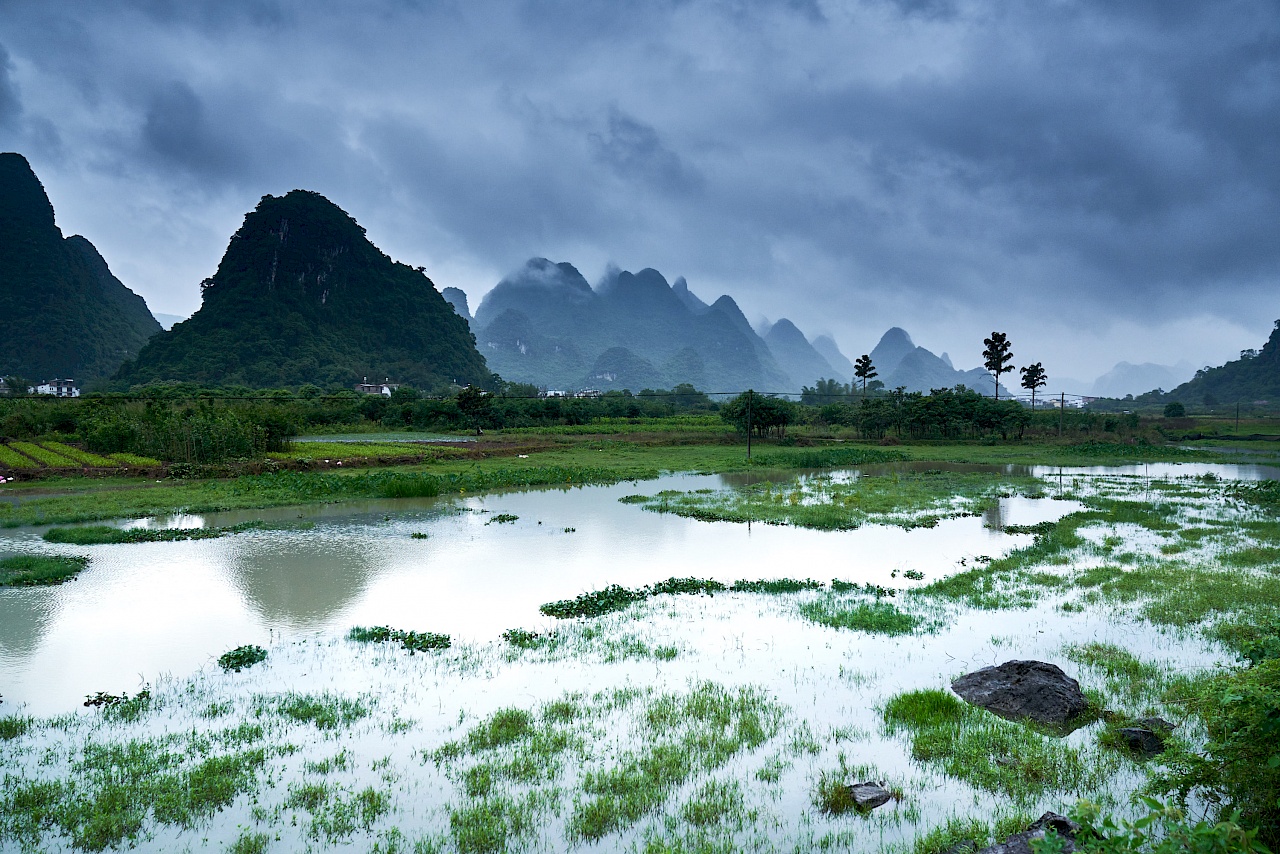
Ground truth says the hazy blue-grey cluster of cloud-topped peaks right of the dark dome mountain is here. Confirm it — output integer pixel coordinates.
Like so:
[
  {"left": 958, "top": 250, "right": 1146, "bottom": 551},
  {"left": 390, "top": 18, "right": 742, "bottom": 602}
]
[{"left": 472, "top": 257, "right": 799, "bottom": 391}]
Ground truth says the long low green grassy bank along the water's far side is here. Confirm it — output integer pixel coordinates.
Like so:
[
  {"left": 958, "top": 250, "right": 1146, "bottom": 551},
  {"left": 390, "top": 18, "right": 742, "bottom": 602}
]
[{"left": 0, "top": 420, "right": 1249, "bottom": 528}]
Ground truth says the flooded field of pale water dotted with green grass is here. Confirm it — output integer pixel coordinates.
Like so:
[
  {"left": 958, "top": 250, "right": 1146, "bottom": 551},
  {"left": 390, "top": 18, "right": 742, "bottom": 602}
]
[{"left": 0, "top": 463, "right": 1280, "bottom": 851}]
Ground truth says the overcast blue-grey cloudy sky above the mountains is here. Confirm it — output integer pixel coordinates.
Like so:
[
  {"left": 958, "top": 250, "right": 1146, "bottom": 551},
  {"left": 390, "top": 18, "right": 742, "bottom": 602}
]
[{"left": 0, "top": 0, "right": 1280, "bottom": 379}]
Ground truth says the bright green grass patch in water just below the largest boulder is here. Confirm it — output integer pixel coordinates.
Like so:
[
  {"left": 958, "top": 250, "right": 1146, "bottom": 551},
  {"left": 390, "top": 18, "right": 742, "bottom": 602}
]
[{"left": 883, "top": 690, "right": 1105, "bottom": 802}]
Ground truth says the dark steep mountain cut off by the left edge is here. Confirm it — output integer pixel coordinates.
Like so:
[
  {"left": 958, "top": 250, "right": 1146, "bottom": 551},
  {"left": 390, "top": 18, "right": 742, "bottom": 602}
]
[{"left": 0, "top": 154, "right": 160, "bottom": 384}]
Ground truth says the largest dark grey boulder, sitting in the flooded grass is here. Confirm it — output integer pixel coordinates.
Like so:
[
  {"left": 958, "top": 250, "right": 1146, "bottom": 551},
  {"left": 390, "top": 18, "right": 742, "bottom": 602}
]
[{"left": 951, "top": 661, "right": 1089, "bottom": 727}]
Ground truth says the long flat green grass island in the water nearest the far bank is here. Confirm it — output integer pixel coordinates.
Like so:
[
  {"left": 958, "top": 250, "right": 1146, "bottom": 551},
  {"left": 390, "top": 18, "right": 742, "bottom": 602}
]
[{"left": 634, "top": 471, "right": 1044, "bottom": 530}]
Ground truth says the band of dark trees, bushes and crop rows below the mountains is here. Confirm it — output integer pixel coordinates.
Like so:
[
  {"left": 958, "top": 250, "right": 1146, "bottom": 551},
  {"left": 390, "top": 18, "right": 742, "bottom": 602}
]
[{"left": 0, "top": 387, "right": 1259, "bottom": 476}]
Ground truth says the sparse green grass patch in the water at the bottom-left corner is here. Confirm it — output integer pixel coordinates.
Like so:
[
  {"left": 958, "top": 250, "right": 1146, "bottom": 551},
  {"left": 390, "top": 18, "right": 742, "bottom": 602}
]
[{"left": 0, "top": 734, "right": 268, "bottom": 851}]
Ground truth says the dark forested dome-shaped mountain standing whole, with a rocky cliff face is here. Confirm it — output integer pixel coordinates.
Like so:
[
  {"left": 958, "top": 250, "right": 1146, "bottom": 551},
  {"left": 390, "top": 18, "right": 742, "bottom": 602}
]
[{"left": 115, "top": 189, "right": 492, "bottom": 389}]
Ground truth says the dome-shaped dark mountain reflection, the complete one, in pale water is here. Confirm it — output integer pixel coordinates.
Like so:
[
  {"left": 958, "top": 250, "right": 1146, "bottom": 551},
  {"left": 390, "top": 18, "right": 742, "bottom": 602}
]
[{"left": 232, "top": 531, "right": 385, "bottom": 629}]
